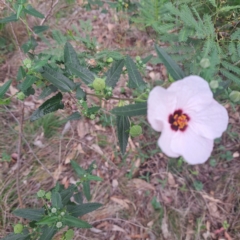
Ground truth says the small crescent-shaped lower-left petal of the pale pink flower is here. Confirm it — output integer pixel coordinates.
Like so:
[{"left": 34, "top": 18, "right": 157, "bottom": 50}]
[{"left": 158, "top": 126, "right": 180, "bottom": 158}]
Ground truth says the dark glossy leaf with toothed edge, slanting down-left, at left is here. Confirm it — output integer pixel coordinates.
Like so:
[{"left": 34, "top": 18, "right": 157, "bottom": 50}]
[{"left": 30, "top": 93, "right": 64, "bottom": 121}]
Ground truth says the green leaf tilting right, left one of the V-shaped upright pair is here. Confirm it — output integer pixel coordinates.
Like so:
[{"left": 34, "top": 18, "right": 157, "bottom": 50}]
[{"left": 106, "top": 59, "right": 124, "bottom": 88}]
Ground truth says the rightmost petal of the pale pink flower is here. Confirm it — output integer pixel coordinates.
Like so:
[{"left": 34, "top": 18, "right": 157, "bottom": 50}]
[{"left": 189, "top": 99, "right": 228, "bottom": 139}]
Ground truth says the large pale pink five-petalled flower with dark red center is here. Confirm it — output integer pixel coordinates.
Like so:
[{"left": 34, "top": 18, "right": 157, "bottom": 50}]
[{"left": 147, "top": 76, "right": 228, "bottom": 164}]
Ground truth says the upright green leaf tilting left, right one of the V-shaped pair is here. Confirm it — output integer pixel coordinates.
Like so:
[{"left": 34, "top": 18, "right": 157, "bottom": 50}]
[{"left": 125, "top": 56, "right": 146, "bottom": 88}]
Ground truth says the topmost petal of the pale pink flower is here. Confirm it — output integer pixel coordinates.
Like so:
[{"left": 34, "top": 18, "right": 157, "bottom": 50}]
[{"left": 167, "top": 75, "right": 213, "bottom": 111}]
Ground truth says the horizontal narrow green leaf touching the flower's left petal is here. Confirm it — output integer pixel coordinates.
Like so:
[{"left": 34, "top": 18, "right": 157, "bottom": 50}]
[{"left": 111, "top": 102, "right": 147, "bottom": 117}]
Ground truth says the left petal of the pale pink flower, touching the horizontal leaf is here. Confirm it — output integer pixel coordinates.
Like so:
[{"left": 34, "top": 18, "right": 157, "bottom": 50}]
[{"left": 147, "top": 86, "right": 176, "bottom": 132}]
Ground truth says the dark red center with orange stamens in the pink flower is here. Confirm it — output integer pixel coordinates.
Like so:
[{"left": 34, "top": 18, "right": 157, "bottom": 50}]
[{"left": 168, "top": 109, "right": 190, "bottom": 131}]
